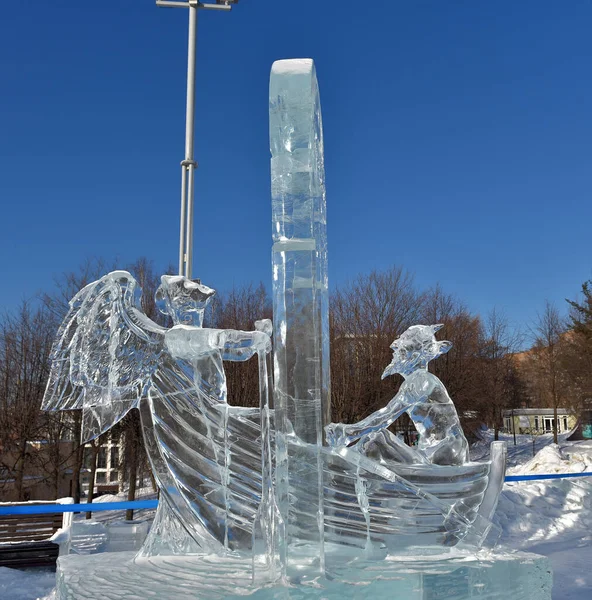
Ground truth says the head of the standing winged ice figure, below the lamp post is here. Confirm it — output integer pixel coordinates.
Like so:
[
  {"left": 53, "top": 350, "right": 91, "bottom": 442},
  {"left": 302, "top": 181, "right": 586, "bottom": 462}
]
[{"left": 156, "top": 275, "right": 216, "bottom": 327}]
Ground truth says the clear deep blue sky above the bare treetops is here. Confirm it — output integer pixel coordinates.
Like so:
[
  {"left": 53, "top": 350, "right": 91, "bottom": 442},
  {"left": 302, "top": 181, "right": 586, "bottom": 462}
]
[{"left": 0, "top": 0, "right": 592, "bottom": 332}]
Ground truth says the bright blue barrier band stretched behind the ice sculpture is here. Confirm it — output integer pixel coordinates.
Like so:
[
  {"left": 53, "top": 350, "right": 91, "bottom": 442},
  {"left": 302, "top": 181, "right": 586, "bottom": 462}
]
[{"left": 0, "top": 472, "right": 592, "bottom": 516}]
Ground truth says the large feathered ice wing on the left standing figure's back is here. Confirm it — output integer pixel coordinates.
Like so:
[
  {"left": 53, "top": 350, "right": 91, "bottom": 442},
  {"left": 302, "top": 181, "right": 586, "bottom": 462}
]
[{"left": 43, "top": 271, "right": 165, "bottom": 439}]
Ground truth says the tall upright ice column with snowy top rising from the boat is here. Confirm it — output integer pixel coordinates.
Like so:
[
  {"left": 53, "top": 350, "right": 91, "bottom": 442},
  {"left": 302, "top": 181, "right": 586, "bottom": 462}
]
[{"left": 269, "top": 59, "right": 330, "bottom": 572}]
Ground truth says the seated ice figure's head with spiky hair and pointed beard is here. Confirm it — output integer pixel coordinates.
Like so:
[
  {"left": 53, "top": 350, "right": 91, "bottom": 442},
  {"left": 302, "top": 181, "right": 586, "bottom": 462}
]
[{"left": 382, "top": 325, "right": 452, "bottom": 379}]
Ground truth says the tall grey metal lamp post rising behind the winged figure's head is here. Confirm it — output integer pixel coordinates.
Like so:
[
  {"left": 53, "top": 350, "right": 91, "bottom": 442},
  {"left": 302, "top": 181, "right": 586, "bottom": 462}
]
[{"left": 156, "top": 0, "right": 238, "bottom": 279}]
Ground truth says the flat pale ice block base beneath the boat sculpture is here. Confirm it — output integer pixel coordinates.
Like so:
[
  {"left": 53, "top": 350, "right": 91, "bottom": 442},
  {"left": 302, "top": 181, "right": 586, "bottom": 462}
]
[{"left": 57, "top": 552, "right": 552, "bottom": 600}]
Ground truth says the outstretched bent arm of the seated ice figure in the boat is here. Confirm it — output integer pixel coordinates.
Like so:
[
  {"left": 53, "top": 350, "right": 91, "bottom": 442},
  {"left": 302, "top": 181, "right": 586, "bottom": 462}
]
[{"left": 325, "top": 387, "right": 417, "bottom": 446}]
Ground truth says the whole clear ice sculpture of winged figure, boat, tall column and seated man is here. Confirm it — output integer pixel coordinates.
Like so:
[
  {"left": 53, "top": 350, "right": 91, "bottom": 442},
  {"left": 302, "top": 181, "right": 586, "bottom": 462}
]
[{"left": 44, "top": 60, "right": 520, "bottom": 600}]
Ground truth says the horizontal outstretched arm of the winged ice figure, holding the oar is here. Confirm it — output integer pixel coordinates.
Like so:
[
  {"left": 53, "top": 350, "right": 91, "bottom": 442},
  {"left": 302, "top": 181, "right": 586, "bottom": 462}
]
[{"left": 165, "top": 325, "right": 271, "bottom": 361}]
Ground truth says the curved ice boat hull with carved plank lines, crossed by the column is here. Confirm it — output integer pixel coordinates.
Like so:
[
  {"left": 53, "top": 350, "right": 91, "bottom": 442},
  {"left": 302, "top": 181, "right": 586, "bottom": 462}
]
[{"left": 147, "top": 370, "right": 503, "bottom": 551}]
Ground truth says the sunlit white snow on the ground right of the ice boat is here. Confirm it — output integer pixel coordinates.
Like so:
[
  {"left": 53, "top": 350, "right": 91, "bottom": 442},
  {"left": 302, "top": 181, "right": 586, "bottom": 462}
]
[{"left": 494, "top": 436, "right": 592, "bottom": 600}]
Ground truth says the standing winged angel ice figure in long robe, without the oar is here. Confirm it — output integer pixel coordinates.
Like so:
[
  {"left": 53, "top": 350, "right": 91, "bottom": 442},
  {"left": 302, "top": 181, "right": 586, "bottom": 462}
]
[{"left": 43, "top": 271, "right": 271, "bottom": 553}]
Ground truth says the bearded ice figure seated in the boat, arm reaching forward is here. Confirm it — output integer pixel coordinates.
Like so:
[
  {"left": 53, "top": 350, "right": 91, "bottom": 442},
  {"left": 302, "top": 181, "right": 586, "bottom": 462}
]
[{"left": 325, "top": 325, "right": 469, "bottom": 465}]
